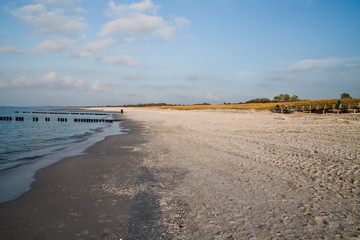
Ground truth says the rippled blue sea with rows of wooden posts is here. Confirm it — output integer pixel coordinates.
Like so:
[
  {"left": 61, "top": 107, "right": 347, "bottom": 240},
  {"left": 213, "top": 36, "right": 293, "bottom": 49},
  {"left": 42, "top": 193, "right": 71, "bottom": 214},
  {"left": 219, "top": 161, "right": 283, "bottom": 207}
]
[{"left": 0, "top": 106, "right": 126, "bottom": 203}]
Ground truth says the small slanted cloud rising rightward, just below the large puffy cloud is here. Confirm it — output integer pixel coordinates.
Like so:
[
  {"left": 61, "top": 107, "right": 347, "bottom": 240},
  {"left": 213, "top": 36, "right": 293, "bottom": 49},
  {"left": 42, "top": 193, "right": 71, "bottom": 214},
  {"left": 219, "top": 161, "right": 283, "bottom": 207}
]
[{"left": 71, "top": 38, "right": 115, "bottom": 58}]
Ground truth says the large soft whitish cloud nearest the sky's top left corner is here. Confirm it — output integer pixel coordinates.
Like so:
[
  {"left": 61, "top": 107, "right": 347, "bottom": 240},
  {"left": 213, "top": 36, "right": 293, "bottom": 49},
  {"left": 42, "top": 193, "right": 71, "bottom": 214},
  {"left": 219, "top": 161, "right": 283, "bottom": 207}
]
[{"left": 11, "top": 4, "right": 88, "bottom": 35}]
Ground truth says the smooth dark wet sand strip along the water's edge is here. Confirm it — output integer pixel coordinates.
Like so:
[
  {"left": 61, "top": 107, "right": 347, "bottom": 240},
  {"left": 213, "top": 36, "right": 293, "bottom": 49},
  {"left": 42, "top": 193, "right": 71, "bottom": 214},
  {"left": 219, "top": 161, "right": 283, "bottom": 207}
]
[{"left": 0, "top": 120, "right": 154, "bottom": 239}]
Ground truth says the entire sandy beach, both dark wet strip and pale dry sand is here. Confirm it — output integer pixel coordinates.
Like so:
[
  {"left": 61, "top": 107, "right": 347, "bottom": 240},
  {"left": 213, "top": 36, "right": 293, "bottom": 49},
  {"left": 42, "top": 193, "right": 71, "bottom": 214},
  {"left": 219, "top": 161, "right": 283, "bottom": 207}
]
[{"left": 0, "top": 108, "right": 360, "bottom": 239}]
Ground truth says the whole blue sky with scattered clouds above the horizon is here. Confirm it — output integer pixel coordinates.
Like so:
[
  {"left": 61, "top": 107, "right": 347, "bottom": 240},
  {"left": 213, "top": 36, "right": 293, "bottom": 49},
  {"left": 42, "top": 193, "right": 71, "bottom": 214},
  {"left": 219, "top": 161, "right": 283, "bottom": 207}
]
[{"left": 0, "top": 0, "right": 360, "bottom": 106}]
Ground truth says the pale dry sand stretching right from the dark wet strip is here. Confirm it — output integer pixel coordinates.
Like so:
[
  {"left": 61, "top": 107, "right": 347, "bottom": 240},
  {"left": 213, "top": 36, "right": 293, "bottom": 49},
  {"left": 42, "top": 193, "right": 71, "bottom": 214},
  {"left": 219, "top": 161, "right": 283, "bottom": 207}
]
[{"left": 95, "top": 108, "right": 360, "bottom": 239}]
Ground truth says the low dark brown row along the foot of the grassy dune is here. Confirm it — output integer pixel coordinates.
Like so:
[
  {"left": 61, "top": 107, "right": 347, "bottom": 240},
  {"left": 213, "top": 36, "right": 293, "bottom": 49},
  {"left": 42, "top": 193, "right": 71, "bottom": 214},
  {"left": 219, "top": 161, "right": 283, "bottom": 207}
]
[{"left": 274, "top": 103, "right": 360, "bottom": 114}]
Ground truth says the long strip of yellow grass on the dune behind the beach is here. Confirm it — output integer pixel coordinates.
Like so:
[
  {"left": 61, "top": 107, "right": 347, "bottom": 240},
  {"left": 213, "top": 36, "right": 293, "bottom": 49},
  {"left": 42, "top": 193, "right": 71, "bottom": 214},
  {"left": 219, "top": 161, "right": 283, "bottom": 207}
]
[{"left": 146, "top": 98, "right": 360, "bottom": 110}]
